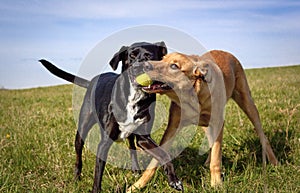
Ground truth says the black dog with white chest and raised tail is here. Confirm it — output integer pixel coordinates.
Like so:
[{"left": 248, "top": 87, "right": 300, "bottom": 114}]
[{"left": 40, "top": 42, "right": 183, "bottom": 192}]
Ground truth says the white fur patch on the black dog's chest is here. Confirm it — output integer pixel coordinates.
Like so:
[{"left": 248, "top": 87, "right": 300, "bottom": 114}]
[{"left": 118, "top": 82, "right": 145, "bottom": 139}]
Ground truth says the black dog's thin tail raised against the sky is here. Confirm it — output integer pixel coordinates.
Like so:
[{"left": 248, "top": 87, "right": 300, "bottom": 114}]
[{"left": 39, "top": 59, "right": 90, "bottom": 88}]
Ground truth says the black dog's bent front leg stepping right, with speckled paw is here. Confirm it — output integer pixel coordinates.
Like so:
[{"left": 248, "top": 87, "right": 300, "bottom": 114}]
[{"left": 136, "top": 135, "right": 183, "bottom": 191}]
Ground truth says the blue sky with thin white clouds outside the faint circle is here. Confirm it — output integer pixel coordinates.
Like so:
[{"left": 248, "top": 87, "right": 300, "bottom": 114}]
[{"left": 0, "top": 0, "right": 300, "bottom": 89}]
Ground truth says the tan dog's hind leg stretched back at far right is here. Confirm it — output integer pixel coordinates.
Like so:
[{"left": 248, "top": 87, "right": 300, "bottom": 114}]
[{"left": 232, "top": 72, "right": 278, "bottom": 165}]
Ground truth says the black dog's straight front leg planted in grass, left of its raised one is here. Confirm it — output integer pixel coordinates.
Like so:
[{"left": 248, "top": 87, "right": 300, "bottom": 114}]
[{"left": 92, "top": 135, "right": 113, "bottom": 193}]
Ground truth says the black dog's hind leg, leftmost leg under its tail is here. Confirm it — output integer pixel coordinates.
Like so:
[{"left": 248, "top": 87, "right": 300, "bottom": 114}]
[{"left": 75, "top": 103, "right": 96, "bottom": 180}]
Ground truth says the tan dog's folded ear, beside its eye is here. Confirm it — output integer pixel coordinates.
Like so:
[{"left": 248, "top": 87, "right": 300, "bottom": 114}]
[{"left": 193, "top": 61, "right": 212, "bottom": 83}]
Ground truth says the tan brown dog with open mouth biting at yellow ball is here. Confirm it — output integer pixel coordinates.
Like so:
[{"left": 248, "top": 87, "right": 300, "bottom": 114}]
[{"left": 128, "top": 50, "right": 278, "bottom": 192}]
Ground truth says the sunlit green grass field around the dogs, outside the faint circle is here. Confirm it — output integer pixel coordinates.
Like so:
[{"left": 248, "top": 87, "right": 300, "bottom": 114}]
[{"left": 0, "top": 66, "right": 300, "bottom": 193}]
